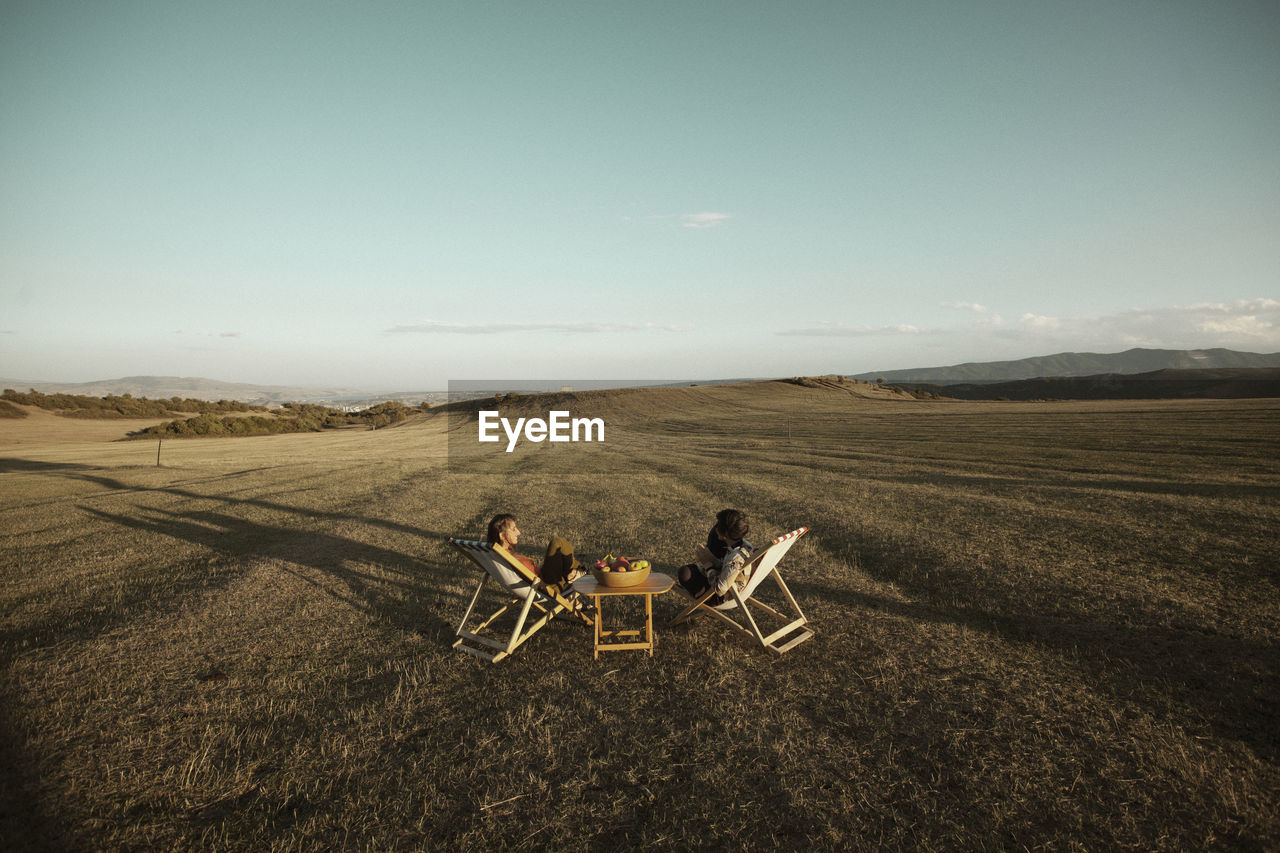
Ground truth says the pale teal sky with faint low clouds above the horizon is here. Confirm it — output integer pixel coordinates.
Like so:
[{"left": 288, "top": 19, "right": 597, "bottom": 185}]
[{"left": 0, "top": 0, "right": 1280, "bottom": 391}]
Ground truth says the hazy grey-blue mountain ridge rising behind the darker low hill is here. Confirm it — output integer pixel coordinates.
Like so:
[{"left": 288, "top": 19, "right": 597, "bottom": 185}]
[{"left": 850, "top": 348, "right": 1280, "bottom": 386}]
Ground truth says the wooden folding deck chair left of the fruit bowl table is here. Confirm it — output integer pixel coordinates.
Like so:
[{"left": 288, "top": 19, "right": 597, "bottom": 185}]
[{"left": 449, "top": 537, "right": 595, "bottom": 663}]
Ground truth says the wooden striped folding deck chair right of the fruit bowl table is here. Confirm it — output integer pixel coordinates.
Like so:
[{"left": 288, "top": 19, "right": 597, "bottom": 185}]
[{"left": 671, "top": 528, "right": 813, "bottom": 654}]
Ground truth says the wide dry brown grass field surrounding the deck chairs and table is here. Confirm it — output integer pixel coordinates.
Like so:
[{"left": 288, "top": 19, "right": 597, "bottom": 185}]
[{"left": 0, "top": 383, "right": 1280, "bottom": 850}]
